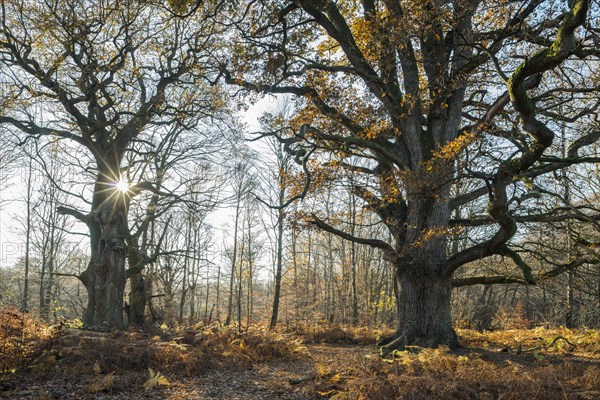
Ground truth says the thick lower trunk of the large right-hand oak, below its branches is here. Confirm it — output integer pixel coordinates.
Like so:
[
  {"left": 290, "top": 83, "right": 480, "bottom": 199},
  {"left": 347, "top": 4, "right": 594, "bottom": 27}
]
[{"left": 380, "top": 194, "right": 458, "bottom": 354}]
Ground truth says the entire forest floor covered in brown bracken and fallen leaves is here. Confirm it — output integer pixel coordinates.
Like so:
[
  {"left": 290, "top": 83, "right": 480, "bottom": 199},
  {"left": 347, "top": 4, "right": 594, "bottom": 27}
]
[{"left": 0, "top": 313, "right": 600, "bottom": 400}]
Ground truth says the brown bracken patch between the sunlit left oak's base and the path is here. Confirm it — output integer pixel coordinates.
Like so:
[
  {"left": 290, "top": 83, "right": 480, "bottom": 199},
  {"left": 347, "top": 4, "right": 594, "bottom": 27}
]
[{"left": 25, "top": 324, "right": 305, "bottom": 376}]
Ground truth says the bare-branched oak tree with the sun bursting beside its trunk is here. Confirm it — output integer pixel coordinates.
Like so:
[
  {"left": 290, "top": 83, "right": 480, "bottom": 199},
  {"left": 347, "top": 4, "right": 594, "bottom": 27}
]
[{"left": 0, "top": 0, "right": 222, "bottom": 328}]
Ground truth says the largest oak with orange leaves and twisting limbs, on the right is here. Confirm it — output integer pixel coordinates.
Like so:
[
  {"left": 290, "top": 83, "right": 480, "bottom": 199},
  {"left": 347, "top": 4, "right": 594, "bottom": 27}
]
[{"left": 221, "top": 0, "right": 600, "bottom": 352}]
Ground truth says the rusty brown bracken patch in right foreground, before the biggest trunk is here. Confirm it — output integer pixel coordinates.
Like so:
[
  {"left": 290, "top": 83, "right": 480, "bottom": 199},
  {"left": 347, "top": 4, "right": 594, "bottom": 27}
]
[{"left": 320, "top": 348, "right": 600, "bottom": 400}]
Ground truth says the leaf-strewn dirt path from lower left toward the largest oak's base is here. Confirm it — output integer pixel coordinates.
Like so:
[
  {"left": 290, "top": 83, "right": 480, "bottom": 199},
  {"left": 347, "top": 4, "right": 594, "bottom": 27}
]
[{"left": 0, "top": 344, "right": 373, "bottom": 400}]
